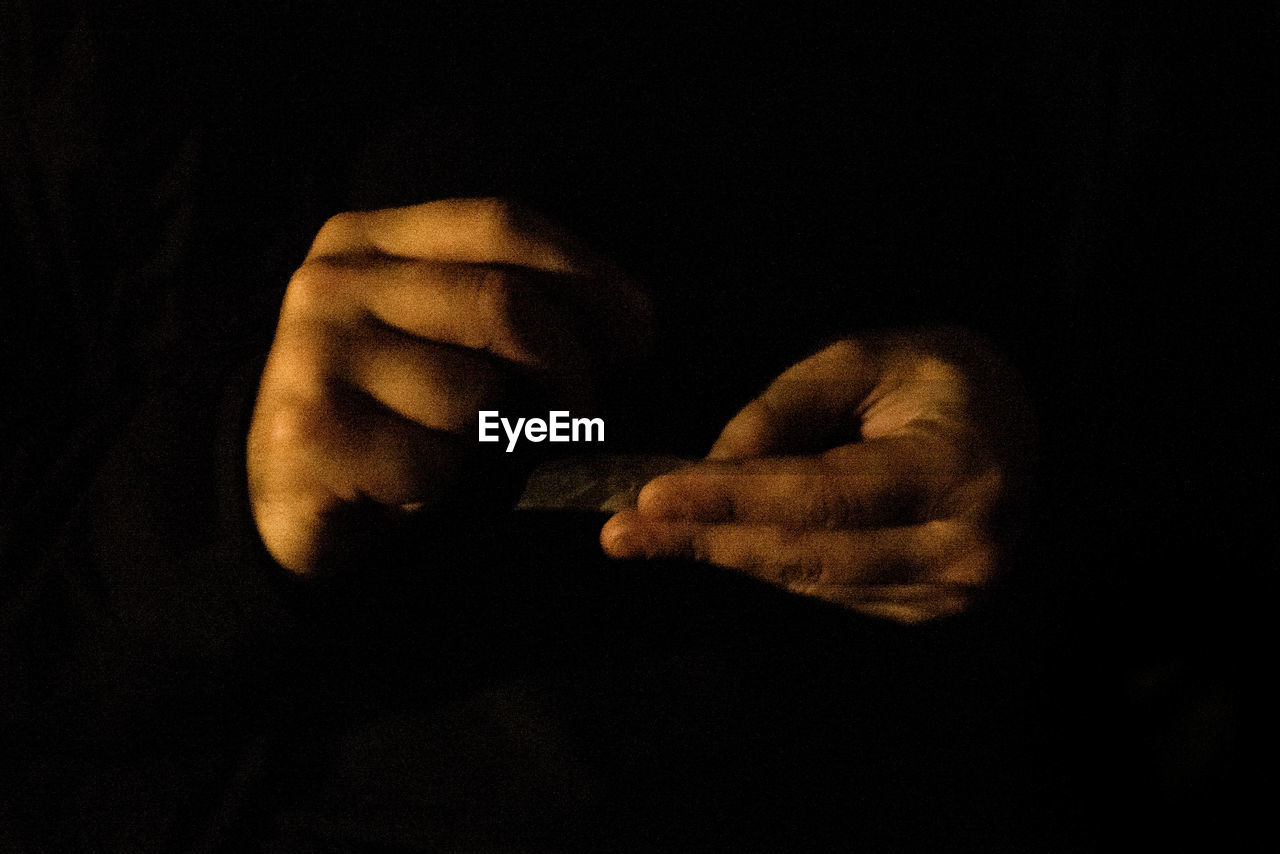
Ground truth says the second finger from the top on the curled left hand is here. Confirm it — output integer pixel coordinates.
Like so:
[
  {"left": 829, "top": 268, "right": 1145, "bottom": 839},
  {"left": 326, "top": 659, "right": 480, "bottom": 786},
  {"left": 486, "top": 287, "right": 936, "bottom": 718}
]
[{"left": 280, "top": 257, "right": 585, "bottom": 374}]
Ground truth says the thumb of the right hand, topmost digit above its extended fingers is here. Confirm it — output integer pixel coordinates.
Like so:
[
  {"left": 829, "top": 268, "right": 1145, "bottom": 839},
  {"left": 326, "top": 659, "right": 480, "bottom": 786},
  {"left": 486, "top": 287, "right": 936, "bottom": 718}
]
[{"left": 708, "top": 341, "right": 879, "bottom": 460}]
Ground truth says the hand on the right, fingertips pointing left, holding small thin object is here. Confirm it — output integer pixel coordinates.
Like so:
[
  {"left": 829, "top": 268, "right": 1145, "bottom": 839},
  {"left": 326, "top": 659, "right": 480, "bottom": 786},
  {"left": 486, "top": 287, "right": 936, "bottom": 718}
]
[{"left": 600, "top": 330, "right": 1030, "bottom": 622}]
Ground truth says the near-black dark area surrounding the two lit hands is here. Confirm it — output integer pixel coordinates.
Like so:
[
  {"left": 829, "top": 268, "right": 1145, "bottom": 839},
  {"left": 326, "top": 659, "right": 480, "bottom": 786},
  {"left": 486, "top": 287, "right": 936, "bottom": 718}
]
[{"left": 0, "top": 3, "right": 1274, "bottom": 850}]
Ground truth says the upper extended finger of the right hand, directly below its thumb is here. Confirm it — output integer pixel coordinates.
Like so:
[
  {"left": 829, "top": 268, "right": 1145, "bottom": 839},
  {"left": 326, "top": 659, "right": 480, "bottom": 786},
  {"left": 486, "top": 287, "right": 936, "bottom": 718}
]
[{"left": 636, "top": 438, "right": 947, "bottom": 529}]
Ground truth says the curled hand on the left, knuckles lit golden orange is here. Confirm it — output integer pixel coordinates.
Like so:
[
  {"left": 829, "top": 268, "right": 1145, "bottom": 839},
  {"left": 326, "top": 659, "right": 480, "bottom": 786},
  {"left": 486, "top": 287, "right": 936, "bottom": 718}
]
[{"left": 246, "top": 200, "right": 648, "bottom": 574}]
